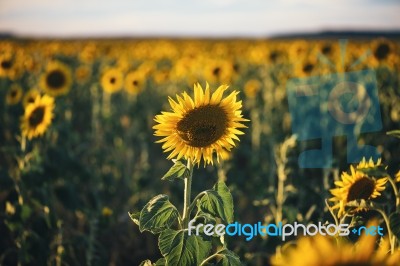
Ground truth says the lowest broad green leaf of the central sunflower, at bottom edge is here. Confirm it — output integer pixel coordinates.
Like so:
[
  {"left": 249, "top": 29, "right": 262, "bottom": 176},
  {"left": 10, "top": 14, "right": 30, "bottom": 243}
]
[{"left": 158, "top": 229, "right": 211, "bottom": 266}]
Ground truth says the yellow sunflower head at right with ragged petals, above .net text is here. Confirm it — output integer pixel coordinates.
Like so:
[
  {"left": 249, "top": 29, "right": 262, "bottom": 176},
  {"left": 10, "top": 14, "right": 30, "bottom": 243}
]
[{"left": 329, "top": 159, "right": 388, "bottom": 217}]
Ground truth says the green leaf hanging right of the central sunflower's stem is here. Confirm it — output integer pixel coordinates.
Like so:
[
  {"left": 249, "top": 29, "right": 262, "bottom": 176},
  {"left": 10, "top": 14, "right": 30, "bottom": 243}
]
[{"left": 199, "top": 181, "right": 233, "bottom": 223}]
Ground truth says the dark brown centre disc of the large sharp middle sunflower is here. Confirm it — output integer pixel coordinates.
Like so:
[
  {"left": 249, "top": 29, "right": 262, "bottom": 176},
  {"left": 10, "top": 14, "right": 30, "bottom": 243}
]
[{"left": 177, "top": 105, "right": 228, "bottom": 147}]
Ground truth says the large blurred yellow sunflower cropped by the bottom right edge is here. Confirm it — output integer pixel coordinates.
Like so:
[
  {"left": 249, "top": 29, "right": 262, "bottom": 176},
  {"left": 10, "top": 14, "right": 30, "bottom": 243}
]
[{"left": 271, "top": 231, "right": 400, "bottom": 266}]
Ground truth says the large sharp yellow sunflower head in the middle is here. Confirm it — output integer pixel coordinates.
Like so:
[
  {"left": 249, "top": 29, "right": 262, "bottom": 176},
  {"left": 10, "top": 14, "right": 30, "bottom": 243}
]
[{"left": 153, "top": 84, "right": 249, "bottom": 165}]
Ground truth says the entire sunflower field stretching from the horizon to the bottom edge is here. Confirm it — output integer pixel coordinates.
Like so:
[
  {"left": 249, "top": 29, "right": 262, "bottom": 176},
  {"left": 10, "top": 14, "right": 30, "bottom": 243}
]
[{"left": 0, "top": 38, "right": 400, "bottom": 266}]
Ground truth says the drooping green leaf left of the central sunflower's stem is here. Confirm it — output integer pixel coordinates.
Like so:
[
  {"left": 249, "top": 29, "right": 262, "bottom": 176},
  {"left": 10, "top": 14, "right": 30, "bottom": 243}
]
[{"left": 139, "top": 194, "right": 179, "bottom": 234}]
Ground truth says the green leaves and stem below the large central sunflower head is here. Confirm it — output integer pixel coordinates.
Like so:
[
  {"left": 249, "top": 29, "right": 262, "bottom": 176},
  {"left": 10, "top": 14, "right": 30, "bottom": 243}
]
[{"left": 133, "top": 161, "right": 240, "bottom": 266}]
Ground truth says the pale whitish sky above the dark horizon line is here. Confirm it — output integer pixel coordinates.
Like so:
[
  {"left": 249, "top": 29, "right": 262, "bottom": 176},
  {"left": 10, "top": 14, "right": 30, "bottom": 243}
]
[{"left": 0, "top": 0, "right": 400, "bottom": 37}]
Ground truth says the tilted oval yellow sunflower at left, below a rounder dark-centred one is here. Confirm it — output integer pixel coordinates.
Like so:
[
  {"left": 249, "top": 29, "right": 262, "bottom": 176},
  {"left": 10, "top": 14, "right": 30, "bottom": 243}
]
[{"left": 21, "top": 95, "right": 54, "bottom": 139}]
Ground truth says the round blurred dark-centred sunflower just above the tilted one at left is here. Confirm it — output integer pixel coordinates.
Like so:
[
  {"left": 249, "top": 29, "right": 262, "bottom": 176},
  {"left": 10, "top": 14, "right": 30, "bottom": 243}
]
[{"left": 40, "top": 61, "right": 72, "bottom": 97}]
